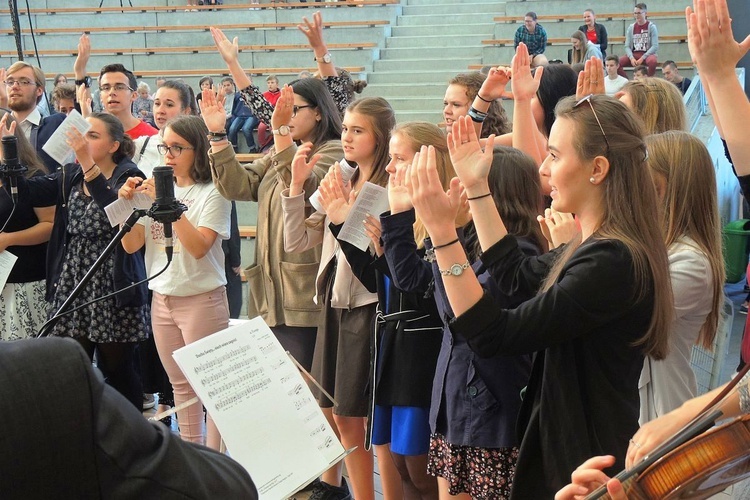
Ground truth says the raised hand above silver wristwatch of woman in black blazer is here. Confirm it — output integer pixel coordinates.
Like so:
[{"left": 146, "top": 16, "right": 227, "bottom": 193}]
[{"left": 409, "top": 146, "right": 461, "bottom": 238}]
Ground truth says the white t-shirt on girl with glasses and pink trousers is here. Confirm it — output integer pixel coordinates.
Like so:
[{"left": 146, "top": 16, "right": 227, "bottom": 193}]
[{"left": 138, "top": 182, "right": 232, "bottom": 297}]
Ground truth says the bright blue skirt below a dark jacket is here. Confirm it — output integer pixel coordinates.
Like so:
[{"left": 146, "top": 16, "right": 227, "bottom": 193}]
[{"left": 372, "top": 405, "right": 430, "bottom": 456}]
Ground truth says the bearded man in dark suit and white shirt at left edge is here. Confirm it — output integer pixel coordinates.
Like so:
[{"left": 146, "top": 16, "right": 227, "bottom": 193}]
[{"left": 0, "top": 61, "right": 65, "bottom": 173}]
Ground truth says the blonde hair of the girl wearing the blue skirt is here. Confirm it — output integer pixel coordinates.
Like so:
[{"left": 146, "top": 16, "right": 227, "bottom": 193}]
[{"left": 391, "top": 122, "right": 456, "bottom": 248}]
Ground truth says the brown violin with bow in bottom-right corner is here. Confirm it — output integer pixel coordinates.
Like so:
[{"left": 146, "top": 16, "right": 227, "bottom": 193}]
[{"left": 586, "top": 364, "right": 750, "bottom": 500}]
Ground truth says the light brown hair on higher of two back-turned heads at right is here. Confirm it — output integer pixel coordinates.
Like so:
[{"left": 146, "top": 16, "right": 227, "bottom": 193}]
[{"left": 622, "top": 78, "right": 687, "bottom": 134}]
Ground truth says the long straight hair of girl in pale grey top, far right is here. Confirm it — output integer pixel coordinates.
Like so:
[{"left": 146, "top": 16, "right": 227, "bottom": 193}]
[{"left": 646, "top": 131, "right": 724, "bottom": 349}]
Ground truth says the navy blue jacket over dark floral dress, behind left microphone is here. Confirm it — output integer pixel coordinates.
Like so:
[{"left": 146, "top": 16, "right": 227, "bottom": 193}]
[{"left": 46, "top": 158, "right": 148, "bottom": 307}]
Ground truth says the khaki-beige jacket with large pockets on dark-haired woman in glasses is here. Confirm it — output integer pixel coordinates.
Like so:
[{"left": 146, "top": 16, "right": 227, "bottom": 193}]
[{"left": 209, "top": 140, "right": 344, "bottom": 326}]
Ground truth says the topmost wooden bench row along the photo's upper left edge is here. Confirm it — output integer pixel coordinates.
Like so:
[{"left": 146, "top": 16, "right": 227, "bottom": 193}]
[{"left": 0, "top": 0, "right": 400, "bottom": 15}]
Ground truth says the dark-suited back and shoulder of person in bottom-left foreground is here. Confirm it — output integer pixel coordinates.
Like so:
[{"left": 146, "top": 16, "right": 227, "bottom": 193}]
[{"left": 0, "top": 338, "right": 258, "bottom": 500}]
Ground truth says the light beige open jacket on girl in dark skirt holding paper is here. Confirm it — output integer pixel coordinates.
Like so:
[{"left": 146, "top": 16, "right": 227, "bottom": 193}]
[{"left": 281, "top": 189, "right": 378, "bottom": 309}]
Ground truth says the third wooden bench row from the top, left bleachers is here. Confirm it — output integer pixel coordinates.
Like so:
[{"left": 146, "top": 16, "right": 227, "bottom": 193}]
[{"left": 0, "top": 42, "right": 377, "bottom": 57}]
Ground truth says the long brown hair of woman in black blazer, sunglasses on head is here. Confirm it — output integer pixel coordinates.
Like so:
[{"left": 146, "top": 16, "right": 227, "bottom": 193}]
[{"left": 542, "top": 95, "right": 674, "bottom": 359}]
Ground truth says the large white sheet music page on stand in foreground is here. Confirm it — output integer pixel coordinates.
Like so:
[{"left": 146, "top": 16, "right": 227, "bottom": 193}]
[{"left": 173, "top": 318, "right": 344, "bottom": 500}]
